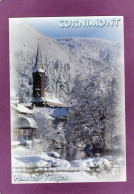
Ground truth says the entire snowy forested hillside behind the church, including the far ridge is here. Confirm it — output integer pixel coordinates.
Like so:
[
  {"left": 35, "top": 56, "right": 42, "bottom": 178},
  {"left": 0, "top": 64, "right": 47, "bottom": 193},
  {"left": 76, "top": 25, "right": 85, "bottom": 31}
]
[{"left": 10, "top": 20, "right": 122, "bottom": 101}]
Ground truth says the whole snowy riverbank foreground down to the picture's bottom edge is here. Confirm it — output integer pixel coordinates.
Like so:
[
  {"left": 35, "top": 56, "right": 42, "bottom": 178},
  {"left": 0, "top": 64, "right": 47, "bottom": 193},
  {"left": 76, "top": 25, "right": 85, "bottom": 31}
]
[{"left": 12, "top": 146, "right": 124, "bottom": 182}]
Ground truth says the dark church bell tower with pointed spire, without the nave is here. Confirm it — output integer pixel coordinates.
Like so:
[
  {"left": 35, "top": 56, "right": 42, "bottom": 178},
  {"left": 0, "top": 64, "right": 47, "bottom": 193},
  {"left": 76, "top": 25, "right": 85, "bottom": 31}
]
[{"left": 32, "top": 45, "right": 45, "bottom": 107}]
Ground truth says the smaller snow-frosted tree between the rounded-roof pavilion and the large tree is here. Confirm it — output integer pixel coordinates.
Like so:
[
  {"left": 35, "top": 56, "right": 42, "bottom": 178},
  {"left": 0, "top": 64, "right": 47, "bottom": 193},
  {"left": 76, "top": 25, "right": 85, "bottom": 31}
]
[{"left": 32, "top": 108, "right": 66, "bottom": 152}]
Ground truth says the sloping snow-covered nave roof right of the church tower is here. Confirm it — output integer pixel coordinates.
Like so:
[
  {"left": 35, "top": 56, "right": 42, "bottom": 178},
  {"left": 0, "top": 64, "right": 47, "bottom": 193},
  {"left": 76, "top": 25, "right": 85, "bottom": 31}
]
[{"left": 45, "top": 92, "right": 62, "bottom": 106}]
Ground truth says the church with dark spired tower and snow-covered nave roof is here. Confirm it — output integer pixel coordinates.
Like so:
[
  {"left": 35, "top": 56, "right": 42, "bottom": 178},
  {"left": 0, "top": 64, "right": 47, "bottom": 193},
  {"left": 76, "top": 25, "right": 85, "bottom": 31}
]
[{"left": 31, "top": 45, "right": 62, "bottom": 107}]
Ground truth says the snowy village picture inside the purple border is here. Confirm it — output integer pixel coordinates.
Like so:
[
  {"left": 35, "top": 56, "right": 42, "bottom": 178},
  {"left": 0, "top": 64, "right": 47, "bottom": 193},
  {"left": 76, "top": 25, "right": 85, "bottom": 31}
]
[{"left": 9, "top": 16, "right": 126, "bottom": 184}]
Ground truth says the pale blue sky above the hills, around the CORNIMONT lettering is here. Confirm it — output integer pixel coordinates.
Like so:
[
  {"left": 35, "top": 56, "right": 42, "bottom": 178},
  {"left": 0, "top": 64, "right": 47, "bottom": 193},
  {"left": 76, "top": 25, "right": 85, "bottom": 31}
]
[{"left": 19, "top": 16, "right": 124, "bottom": 42}]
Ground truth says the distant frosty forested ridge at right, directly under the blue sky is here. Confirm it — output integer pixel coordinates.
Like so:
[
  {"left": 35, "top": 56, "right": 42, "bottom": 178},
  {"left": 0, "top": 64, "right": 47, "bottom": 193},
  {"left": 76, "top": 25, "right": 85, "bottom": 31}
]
[{"left": 56, "top": 37, "right": 123, "bottom": 65}]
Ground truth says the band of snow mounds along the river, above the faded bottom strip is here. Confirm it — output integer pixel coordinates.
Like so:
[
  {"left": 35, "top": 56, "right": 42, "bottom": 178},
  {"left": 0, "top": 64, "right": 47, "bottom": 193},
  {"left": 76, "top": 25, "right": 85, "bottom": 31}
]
[{"left": 12, "top": 146, "right": 124, "bottom": 171}]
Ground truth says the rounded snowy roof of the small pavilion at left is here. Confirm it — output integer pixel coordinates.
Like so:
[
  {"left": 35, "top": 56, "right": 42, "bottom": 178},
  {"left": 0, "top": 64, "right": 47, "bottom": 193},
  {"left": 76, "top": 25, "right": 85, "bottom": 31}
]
[{"left": 14, "top": 117, "right": 37, "bottom": 129}]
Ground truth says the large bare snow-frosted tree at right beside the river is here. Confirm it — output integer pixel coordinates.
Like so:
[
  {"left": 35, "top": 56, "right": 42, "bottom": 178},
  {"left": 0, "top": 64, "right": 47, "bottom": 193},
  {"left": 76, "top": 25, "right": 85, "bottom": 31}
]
[{"left": 66, "top": 67, "right": 123, "bottom": 153}]
